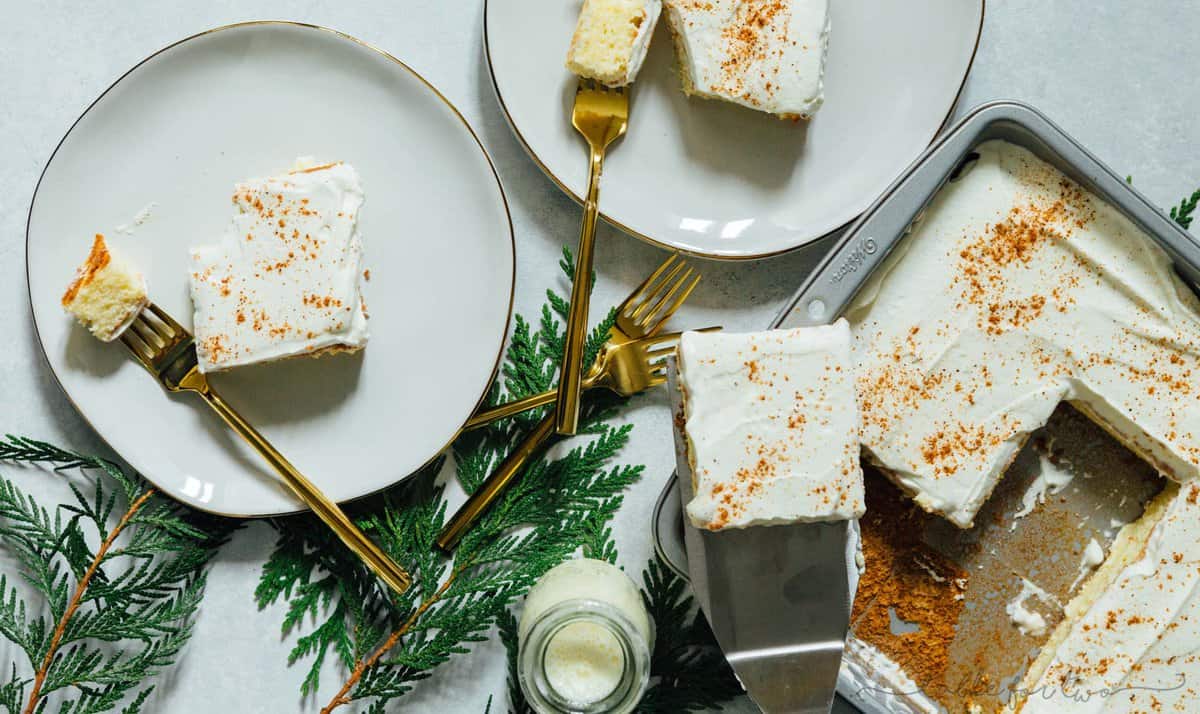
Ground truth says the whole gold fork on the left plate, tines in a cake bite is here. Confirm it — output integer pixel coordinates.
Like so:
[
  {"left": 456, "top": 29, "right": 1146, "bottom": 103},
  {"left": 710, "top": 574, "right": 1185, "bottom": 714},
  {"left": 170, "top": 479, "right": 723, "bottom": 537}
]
[{"left": 121, "top": 302, "right": 412, "bottom": 593}]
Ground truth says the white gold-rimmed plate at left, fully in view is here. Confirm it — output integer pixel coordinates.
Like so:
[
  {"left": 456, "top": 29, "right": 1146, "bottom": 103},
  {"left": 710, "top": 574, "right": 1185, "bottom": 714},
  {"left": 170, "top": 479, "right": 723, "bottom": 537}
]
[{"left": 26, "top": 22, "right": 515, "bottom": 516}]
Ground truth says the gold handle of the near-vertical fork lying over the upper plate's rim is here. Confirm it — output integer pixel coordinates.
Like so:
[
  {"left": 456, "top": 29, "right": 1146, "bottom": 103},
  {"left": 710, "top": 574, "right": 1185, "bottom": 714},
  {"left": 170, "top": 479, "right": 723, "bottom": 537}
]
[{"left": 554, "top": 145, "right": 604, "bottom": 434}]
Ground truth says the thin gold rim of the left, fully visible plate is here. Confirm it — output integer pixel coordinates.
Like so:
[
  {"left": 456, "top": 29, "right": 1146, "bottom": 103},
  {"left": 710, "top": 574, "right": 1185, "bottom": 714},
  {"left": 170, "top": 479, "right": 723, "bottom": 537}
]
[{"left": 25, "top": 20, "right": 517, "bottom": 518}]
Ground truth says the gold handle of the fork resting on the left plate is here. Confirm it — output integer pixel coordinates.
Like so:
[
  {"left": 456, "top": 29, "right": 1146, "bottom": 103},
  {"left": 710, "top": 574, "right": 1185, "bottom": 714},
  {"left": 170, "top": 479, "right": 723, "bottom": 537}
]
[{"left": 199, "top": 389, "right": 413, "bottom": 593}]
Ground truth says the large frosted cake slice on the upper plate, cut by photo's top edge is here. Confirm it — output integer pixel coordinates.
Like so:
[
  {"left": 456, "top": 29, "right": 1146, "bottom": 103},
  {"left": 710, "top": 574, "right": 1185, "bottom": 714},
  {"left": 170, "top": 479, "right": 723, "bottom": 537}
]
[{"left": 665, "top": 0, "right": 829, "bottom": 119}]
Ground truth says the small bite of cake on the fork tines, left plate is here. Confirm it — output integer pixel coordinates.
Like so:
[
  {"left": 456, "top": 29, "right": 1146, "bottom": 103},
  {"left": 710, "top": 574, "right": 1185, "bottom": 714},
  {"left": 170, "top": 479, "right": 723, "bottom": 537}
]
[{"left": 62, "top": 233, "right": 149, "bottom": 342}]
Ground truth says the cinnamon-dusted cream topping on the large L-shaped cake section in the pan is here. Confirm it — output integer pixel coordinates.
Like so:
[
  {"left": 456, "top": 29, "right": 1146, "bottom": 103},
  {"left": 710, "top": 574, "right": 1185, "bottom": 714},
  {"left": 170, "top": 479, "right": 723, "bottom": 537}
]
[{"left": 847, "top": 142, "right": 1200, "bottom": 528}]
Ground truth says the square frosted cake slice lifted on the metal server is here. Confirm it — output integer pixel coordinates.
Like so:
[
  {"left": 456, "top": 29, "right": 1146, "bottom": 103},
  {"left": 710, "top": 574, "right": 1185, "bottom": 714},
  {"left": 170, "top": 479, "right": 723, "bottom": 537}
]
[{"left": 679, "top": 320, "right": 864, "bottom": 530}]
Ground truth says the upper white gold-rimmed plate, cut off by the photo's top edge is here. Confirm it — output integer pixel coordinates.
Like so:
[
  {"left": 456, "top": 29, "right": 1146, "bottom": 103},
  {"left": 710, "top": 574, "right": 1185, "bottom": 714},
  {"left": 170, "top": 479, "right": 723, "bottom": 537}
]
[{"left": 484, "top": 0, "right": 984, "bottom": 259}]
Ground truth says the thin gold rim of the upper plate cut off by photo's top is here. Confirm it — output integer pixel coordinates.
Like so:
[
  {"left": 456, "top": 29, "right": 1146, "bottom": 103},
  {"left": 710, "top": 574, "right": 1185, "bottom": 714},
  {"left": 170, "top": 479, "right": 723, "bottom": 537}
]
[{"left": 484, "top": 0, "right": 988, "bottom": 262}]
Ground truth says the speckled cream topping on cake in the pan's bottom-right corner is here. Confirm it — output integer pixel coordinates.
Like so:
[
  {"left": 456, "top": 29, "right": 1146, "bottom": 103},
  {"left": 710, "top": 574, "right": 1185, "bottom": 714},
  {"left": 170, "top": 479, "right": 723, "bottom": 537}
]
[{"left": 1019, "top": 484, "right": 1200, "bottom": 714}]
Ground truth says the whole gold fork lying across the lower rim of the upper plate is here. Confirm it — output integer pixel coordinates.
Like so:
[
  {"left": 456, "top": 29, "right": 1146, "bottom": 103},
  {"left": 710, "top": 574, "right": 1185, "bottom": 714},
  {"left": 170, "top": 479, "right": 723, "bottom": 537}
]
[{"left": 554, "top": 78, "right": 629, "bottom": 434}]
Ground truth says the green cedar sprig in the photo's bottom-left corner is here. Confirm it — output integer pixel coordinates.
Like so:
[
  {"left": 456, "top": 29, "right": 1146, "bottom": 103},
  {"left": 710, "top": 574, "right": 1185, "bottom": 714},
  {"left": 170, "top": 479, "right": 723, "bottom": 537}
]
[{"left": 0, "top": 436, "right": 234, "bottom": 714}]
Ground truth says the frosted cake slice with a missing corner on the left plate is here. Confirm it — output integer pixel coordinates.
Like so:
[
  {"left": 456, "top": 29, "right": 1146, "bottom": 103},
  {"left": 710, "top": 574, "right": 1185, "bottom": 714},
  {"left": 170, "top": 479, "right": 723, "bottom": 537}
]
[{"left": 191, "top": 160, "right": 367, "bottom": 372}]
